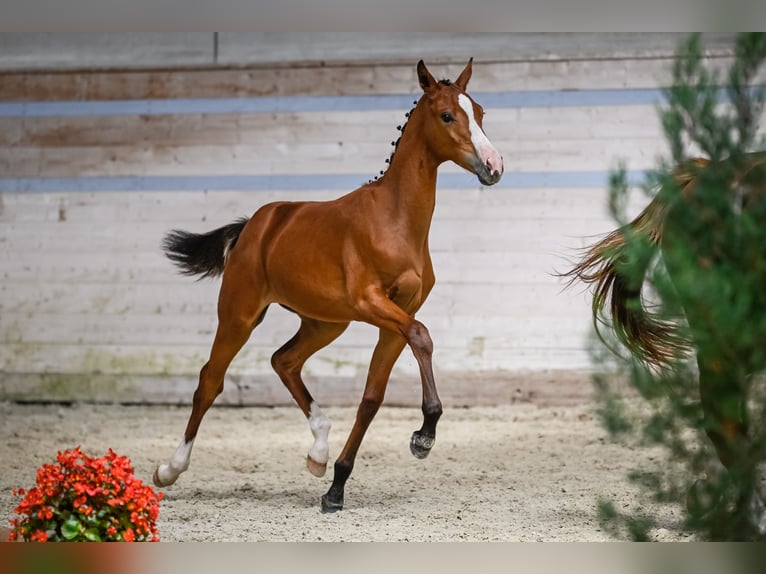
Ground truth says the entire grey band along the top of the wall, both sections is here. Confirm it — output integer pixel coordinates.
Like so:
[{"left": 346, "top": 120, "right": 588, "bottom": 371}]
[{"left": 0, "top": 32, "right": 734, "bottom": 71}]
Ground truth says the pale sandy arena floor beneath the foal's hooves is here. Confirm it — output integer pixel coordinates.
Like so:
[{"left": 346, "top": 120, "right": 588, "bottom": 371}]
[{"left": 0, "top": 402, "right": 691, "bottom": 541}]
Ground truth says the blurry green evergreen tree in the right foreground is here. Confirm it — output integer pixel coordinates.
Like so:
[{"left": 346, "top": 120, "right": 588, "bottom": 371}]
[{"left": 566, "top": 33, "right": 766, "bottom": 540}]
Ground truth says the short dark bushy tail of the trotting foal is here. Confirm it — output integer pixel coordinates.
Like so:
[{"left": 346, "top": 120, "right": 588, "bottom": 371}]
[{"left": 162, "top": 217, "right": 248, "bottom": 279}]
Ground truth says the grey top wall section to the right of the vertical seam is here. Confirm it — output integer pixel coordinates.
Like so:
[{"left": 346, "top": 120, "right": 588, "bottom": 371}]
[{"left": 218, "top": 32, "right": 733, "bottom": 65}]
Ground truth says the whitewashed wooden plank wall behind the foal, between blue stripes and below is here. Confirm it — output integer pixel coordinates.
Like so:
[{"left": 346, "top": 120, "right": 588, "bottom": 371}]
[{"left": 0, "top": 36, "right": 748, "bottom": 403}]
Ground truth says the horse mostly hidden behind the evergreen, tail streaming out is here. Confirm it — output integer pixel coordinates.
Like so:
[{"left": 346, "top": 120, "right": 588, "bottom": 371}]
[{"left": 561, "top": 152, "right": 766, "bottom": 536}]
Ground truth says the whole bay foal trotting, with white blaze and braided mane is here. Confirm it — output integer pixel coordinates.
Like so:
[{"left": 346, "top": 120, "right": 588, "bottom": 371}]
[{"left": 153, "top": 58, "right": 503, "bottom": 512}]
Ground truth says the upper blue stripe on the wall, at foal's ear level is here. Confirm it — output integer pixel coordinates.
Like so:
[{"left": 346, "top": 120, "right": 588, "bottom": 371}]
[{"left": 0, "top": 89, "right": 663, "bottom": 117}]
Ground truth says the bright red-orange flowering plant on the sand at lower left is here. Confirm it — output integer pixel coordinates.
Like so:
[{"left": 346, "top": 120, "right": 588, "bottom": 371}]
[{"left": 8, "top": 446, "right": 162, "bottom": 542}]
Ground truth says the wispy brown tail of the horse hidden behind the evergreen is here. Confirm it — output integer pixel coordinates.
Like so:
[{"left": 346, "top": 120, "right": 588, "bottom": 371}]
[{"left": 560, "top": 191, "right": 688, "bottom": 368}]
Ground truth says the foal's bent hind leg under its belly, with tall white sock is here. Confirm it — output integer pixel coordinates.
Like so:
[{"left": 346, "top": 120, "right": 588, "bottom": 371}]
[{"left": 271, "top": 317, "right": 348, "bottom": 476}]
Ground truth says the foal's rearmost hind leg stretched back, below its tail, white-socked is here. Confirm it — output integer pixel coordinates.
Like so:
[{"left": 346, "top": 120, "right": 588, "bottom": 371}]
[{"left": 153, "top": 276, "right": 266, "bottom": 487}]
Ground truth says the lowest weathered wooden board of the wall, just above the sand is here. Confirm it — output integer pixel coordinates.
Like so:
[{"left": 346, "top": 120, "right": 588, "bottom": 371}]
[{"left": 0, "top": 370, "right": 592, "bottom": 408}]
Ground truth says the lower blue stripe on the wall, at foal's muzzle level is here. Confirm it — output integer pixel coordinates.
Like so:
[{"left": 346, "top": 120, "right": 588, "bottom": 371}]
[{"left": 0, "top": 171, "right": 643, "bottom": 193}]
